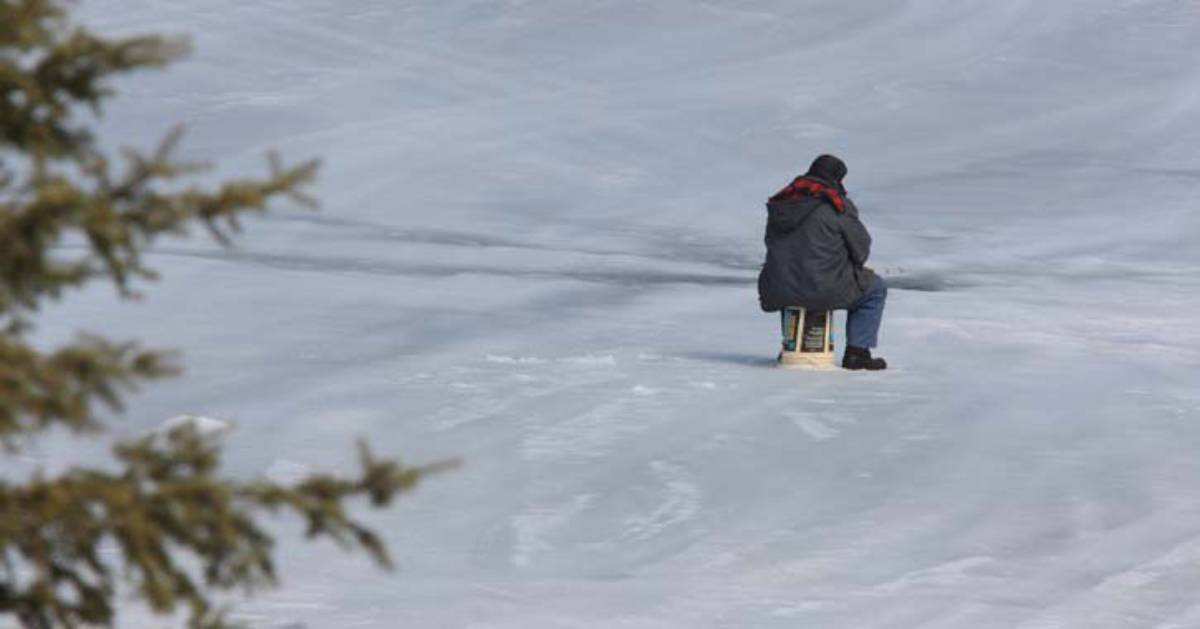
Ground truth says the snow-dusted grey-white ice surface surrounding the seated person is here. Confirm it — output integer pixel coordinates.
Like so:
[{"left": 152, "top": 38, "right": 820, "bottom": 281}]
[{"left": 25, "top": 0, "right": 1200, "bottom": 629}]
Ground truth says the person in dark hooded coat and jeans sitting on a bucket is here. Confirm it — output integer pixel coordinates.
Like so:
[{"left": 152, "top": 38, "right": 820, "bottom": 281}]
[{"left": 758, "top": 155, "right": 887, "bottom": 370}]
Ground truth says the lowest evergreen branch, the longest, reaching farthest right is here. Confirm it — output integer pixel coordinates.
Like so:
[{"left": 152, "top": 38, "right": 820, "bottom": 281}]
[{"left": 0, "top": 425, "right": 452, "bottom": 627}]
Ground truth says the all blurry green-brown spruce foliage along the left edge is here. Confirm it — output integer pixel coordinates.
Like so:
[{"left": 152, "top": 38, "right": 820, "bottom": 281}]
[{"left": 0, "top": 0, "right": 446, "bottom": 628}]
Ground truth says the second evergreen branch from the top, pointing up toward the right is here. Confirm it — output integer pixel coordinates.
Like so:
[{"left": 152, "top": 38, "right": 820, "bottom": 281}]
[{"left": 0, "top": 142, "right": 319, "bottom": 313}]
